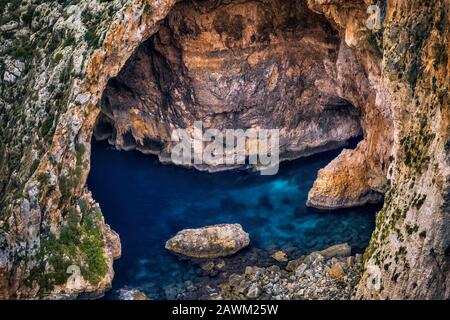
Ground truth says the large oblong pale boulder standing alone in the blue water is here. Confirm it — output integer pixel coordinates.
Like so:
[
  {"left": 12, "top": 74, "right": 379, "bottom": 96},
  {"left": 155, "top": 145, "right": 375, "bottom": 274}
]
[{"left": 166, "top": 224, "right": 250, "bottom": 259}]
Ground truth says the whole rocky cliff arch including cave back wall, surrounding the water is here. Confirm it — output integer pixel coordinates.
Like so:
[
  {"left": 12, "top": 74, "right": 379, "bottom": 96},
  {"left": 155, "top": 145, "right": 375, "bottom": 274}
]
[{"left": 0, "top": 0, "right": 450, "bottom": 299}]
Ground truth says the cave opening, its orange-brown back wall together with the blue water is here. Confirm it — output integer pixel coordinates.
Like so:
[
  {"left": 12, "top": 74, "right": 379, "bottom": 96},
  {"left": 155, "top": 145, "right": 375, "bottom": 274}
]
[{"left": 88, "top": 0, "right": 378, "bottom": 299}]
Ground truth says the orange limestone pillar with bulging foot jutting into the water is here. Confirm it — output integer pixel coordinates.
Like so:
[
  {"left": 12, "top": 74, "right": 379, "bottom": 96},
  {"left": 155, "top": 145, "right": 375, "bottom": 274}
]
[{"left": 307, "top": 1, "right": 393, "bottom": 209}]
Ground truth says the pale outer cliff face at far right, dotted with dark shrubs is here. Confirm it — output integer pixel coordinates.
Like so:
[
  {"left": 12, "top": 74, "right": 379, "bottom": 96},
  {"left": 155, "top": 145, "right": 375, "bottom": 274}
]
[{"left": 356, "top": 1, "right": 450, "bottom": 299}]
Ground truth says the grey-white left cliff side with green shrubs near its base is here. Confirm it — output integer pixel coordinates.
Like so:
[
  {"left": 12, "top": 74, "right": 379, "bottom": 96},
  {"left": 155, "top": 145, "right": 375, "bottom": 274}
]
[{"left": 0, "top": 0, "right": 179, "bottom": 299}]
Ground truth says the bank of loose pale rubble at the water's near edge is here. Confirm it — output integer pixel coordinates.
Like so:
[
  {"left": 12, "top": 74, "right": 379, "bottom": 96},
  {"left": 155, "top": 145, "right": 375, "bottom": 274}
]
[{"left": 217, "top": 245, "right": 362, "bottom": 300}]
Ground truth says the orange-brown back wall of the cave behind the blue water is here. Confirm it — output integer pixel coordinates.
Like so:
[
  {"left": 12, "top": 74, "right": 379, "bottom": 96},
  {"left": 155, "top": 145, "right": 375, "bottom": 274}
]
[{"left": 95, "top": 0, "right": 361, "bottom": 165}]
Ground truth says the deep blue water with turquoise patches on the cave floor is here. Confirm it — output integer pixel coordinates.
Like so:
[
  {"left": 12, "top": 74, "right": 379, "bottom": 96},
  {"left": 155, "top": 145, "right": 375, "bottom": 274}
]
[{"left": 88, "top": 141, "right": 379, "bottom": 299}]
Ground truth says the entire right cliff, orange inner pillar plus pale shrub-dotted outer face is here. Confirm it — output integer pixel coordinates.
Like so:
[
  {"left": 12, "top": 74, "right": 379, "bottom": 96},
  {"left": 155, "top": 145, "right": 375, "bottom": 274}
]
[{"left": 308, "top": 0, "right": 450, "bottom": 299}]
